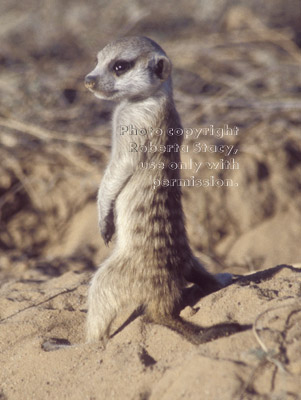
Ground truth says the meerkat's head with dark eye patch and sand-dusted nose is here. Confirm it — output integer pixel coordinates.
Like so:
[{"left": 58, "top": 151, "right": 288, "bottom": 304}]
[{"left": 85, "top": 36, "right": 171, "bottom": 100}]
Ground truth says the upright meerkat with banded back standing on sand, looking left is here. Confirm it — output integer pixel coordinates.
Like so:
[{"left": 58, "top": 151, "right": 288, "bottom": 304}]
[{"left": 85, "top": 37, "right": 230, "bottom": 344}]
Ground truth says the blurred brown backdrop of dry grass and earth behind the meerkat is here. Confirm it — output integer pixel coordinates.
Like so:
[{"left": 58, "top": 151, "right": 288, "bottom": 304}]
[{"left": 0, "top": 0, "right": 301, "bottom": 281}]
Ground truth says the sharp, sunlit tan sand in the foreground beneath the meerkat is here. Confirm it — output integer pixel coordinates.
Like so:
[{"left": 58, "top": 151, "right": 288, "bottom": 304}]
[{"left": 0, "top": 265, "right": 301, "bottom": 400}]
